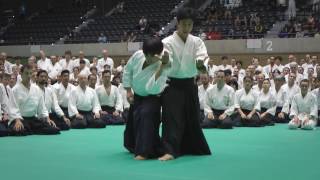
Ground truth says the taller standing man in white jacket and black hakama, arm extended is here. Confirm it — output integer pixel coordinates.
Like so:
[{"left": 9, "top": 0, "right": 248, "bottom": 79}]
[{"left": 159, "top": 8, "right": 211, "bottom": 161}]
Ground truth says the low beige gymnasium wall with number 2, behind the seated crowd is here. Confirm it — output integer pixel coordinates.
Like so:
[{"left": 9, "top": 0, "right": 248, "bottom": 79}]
[{"left": 0, "top": 38, "right": 320, "bottom": 65}]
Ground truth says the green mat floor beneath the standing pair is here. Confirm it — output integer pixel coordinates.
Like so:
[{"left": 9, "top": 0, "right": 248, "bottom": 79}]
[{"left": 0, "top": 125, "right": 320, "bottom": 180}]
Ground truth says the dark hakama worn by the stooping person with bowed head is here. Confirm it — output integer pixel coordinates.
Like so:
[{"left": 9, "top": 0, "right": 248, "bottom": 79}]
[{"left": 124, "top": 94, "right": 163, "bottom": 158}]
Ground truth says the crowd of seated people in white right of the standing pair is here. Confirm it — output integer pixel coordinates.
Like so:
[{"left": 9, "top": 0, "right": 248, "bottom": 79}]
[{"left": 197, "top": 55, "right": 320, "bottom": 129}]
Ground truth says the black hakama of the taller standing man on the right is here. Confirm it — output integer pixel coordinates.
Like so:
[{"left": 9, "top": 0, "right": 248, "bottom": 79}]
[{"left": 162, "top": 78, "right": 211, "bottom": 158}]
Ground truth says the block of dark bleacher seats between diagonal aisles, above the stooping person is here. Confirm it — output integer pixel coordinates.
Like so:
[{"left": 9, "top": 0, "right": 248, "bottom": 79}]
[{"left": 65, "top": 0, "right": 180, "bottom": 43}]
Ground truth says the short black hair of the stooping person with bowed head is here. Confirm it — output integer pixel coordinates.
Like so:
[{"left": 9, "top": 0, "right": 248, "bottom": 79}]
[{"left": 142, "top": 37, "right": 163, "bottom": 56}]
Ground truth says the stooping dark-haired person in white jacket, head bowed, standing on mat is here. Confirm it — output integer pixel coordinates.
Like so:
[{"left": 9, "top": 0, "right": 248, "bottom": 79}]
[{"left": 122, "top": 38, "right": 170, "bottom": 160}]
